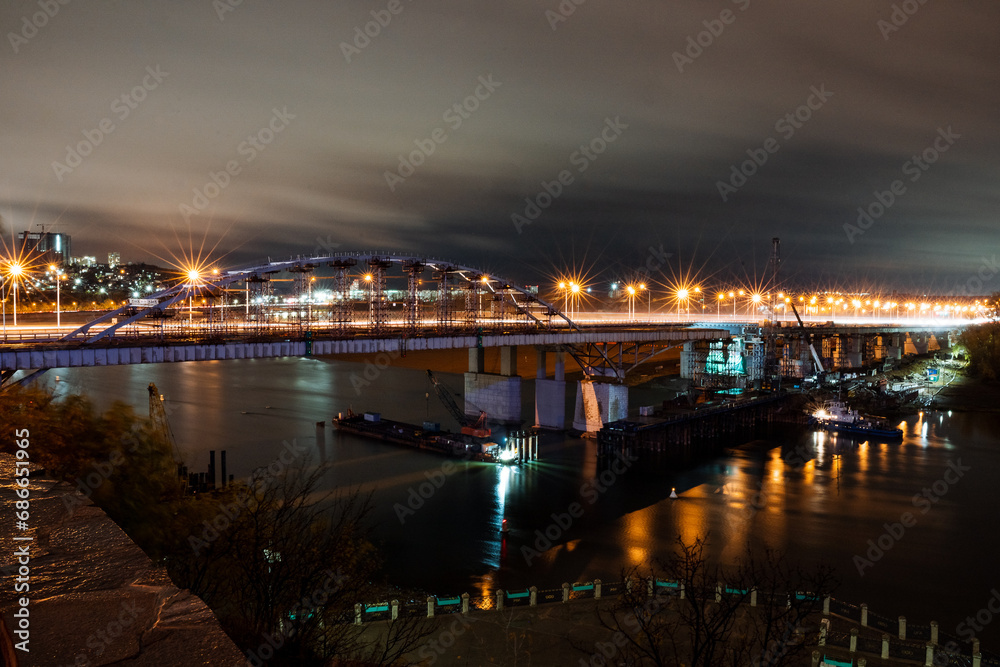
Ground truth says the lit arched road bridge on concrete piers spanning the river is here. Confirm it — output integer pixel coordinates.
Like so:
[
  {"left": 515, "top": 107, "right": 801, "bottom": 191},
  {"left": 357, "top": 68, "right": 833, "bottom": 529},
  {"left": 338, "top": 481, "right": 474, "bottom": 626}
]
[{"left": 0, "top": 253, "right": 968, "bottom": 431}]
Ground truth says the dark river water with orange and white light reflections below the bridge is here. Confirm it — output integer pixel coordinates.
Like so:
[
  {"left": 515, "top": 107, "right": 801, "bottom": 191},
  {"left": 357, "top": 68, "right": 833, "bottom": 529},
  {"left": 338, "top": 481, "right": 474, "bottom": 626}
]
[{"left": 46, "top": 359, "right": 1000, "bottom": 649}]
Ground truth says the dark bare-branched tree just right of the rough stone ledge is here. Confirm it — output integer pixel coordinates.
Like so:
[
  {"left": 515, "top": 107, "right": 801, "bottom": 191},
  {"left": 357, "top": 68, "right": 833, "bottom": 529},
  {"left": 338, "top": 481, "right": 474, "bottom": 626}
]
[{"left": 172, "top": 462, "right": 429, "bottom": 665}]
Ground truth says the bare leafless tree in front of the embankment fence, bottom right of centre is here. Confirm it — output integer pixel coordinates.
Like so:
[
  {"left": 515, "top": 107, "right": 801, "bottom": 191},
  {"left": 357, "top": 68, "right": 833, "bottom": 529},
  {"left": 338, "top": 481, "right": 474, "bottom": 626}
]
[{"left": 578, "top": 537, "right": 835, "bottom": 667}]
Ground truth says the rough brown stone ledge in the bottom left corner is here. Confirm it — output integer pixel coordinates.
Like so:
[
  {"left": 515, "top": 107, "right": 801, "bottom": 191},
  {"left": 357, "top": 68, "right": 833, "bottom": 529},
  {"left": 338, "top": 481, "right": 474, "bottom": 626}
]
[{"left": 0, "top": 454, "right": 246, "bottom": 667}]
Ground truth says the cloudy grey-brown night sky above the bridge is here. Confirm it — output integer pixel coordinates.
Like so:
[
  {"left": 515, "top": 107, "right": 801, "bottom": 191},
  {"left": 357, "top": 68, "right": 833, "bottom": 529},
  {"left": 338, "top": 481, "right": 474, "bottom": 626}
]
[{"left": 0, "top": 0, "right": 1000, "bottom": 293}]
